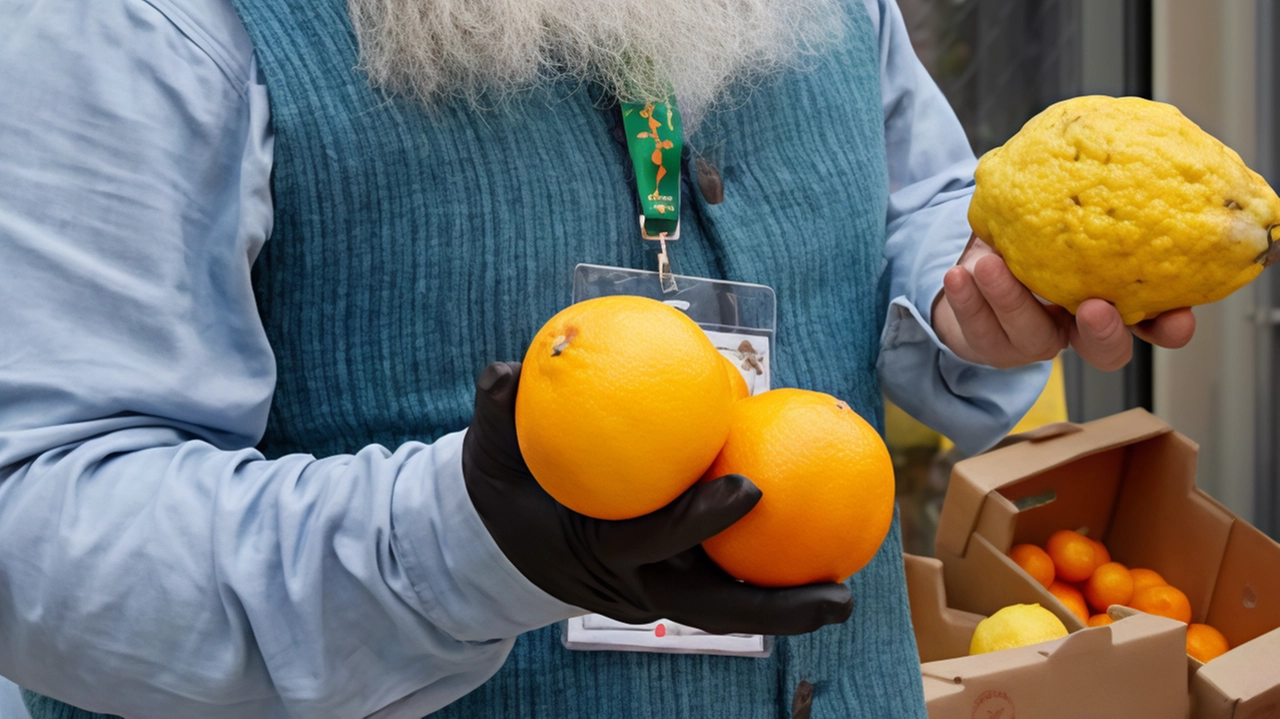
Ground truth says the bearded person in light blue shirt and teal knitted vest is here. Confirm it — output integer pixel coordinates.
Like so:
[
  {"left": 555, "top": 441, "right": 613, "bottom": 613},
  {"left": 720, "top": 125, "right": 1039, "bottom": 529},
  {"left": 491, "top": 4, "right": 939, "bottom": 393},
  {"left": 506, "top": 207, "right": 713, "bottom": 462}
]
[{"left": 0, "top": 0, "right": 1192, "bottom": 719}]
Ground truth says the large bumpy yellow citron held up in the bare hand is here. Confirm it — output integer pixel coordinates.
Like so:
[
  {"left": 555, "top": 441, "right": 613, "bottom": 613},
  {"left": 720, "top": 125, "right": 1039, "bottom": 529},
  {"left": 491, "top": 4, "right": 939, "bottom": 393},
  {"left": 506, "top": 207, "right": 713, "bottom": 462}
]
[{"left": 969, "top": 96, "right": 1280, "bottom": 325}]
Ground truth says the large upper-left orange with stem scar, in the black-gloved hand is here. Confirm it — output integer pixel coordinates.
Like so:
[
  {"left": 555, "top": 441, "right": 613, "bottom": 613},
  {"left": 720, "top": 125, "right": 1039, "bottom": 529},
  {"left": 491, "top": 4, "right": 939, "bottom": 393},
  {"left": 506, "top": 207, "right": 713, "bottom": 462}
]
[{"left": 516, "top": 297, "right": 733, "bottom": 519}]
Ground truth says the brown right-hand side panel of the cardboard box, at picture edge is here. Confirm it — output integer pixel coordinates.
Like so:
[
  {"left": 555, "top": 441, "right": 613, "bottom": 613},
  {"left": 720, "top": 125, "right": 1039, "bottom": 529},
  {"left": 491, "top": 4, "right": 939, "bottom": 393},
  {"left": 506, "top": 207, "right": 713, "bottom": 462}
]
[{"left": 1207, "top": 521, "right": 1280, "bottom": 644}]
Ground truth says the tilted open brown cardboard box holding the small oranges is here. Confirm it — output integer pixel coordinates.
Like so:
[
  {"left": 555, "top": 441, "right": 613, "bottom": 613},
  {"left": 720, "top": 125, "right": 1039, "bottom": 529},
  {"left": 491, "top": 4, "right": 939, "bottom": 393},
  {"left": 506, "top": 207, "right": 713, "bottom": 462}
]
[{"left": 936, "top": 409, "right": 1280, "bottom": 719}]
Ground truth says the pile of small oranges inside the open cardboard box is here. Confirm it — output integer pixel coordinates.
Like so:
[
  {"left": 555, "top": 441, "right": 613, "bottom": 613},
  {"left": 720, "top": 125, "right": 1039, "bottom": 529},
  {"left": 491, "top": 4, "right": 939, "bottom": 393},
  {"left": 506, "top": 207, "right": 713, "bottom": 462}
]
[{"left": 1009, "top": 530, "right": 1230, "bottom": 661}]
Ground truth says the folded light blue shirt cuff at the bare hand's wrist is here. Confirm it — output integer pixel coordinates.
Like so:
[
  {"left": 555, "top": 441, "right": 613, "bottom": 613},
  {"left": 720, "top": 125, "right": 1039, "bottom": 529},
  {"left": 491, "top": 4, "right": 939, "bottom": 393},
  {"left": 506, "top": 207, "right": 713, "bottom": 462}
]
[{"left": 876, "top": 292, "right": 1051, "bottom": 455}]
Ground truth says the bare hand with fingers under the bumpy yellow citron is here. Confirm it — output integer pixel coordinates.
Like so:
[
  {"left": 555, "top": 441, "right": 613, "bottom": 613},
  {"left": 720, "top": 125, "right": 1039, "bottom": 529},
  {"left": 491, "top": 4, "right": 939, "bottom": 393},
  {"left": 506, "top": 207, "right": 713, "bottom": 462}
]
[{"left": 933, "top": 238, "right": 1196, "bottom": 372}]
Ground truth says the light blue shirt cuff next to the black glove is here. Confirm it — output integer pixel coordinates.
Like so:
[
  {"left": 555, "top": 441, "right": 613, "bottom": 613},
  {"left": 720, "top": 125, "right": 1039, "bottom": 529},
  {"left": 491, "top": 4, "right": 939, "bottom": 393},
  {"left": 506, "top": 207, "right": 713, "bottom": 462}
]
[{"left": 392, "top": 431, "right": 584, "bottom": 641}]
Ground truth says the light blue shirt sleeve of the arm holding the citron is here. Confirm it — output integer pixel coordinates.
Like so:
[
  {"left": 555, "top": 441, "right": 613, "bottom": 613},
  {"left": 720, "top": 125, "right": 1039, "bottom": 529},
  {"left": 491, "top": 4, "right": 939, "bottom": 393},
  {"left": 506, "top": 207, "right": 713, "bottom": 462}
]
[{"left": 864, "top": 0, "right": 1050, "bottom": 454}]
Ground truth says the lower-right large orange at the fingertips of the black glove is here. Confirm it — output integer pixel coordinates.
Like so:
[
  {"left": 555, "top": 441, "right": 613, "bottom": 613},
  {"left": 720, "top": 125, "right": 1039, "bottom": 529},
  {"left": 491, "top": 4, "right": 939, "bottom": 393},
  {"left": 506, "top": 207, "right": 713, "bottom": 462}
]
[{"left": 703, "top": 389, "right": 893, "bottom": 587}]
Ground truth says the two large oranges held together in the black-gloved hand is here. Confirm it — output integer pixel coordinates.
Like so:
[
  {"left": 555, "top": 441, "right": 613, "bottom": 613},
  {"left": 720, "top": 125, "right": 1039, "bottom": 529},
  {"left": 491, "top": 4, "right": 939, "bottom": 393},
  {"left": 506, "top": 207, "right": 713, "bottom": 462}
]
[{"left": 516, "top": 296, "right": 893, "bottom": 586}]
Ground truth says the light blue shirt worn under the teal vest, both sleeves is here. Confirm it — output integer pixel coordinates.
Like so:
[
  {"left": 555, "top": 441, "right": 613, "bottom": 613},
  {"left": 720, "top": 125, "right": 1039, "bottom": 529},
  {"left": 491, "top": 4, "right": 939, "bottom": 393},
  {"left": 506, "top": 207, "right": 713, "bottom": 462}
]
[{"left": 0, "top": 0, "right": 1047, "bottom": 719}]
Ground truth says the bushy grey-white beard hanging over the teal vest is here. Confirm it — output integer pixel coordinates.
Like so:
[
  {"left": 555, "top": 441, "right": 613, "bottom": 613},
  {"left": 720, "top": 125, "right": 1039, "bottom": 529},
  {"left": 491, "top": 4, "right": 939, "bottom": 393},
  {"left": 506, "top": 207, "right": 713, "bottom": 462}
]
[{"left": 348, "top": 0, "right": 847, "bottom": 130}]
